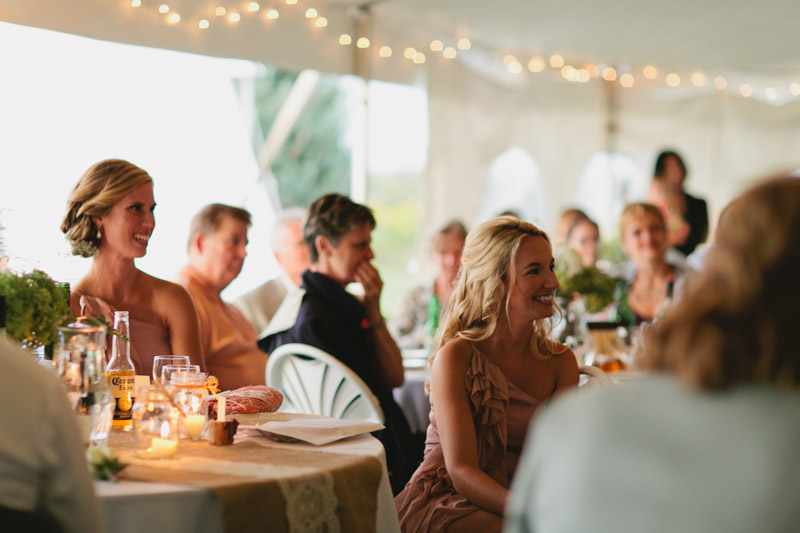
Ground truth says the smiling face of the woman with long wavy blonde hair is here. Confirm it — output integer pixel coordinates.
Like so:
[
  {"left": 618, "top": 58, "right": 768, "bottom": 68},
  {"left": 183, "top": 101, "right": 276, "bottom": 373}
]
[{"left": 505, "top": 237, "right": 558, "bottom": 322}]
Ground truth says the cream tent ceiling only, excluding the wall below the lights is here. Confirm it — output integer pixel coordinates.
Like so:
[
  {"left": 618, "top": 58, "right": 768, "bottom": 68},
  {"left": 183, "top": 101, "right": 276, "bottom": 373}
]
[{"left": 0, "top": 0, "right": 800, "bottom": 88}]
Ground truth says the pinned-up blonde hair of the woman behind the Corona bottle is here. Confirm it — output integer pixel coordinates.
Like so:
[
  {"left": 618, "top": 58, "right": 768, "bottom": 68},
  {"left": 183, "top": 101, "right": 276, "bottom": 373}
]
[{"left": 61, "top": 159, "right": 153, "bottom": 257}]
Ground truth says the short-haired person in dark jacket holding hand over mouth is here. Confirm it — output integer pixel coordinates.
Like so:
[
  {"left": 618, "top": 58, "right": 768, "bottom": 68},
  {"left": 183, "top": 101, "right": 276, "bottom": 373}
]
[{"left": 259, "top": 194, "right": 422, "bottom": 493}]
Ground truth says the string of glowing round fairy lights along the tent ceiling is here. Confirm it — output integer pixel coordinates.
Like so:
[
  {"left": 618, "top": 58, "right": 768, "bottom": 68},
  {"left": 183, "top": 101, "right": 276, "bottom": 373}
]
[{"left": 126, "top": 0, "right": 800, "bottom": 101}]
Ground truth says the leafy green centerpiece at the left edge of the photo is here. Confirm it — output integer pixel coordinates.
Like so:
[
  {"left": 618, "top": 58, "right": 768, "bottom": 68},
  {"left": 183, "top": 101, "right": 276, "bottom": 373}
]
[{"left": 0, "top": 270, "right": 69, "bottom": 350}]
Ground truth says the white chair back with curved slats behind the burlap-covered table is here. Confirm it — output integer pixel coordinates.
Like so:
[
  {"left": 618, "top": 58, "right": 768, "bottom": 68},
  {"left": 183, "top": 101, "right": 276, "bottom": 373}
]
[{"left": 266, "top": 343, "right": 384, "bottom": 424}]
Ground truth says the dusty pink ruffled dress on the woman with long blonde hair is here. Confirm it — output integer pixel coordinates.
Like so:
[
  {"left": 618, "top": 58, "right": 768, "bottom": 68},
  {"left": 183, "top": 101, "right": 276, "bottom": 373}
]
[{"left": 395, "top": 345, "right": 563, "bottom": 532}]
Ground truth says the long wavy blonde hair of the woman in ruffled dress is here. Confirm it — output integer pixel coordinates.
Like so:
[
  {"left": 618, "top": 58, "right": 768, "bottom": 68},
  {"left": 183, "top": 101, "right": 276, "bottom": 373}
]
[{"left": 431, "top": 216, "right": 554, "bottom": 362}]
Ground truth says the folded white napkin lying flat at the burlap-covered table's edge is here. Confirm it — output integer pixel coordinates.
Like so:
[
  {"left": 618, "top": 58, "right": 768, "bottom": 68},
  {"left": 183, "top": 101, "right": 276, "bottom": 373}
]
[{"left": 255, "top": 417, "right": 384, "bottom": 446}]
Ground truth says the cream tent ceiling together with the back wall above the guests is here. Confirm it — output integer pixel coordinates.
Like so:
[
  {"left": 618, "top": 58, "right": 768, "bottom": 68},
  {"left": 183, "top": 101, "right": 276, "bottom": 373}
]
[{"left": 0, "top": 0, "right": 800, "bottom": 235}]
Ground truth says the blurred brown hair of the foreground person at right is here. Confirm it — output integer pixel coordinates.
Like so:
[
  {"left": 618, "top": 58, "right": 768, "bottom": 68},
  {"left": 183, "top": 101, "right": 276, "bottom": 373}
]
[{"left": 645, "top": 178, "right": 800, "bottom": 390}]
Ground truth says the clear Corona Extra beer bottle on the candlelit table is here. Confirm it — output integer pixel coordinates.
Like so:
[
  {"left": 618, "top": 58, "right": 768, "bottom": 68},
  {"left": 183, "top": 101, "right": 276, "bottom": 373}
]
[{"left": 107, "top": 311, "right": 136, "bottom": 428}]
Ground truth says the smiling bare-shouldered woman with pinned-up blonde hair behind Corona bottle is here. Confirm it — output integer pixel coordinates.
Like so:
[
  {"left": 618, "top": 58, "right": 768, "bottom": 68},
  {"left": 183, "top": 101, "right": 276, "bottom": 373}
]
[{"left": 61, "top": 159, "right": 205, "bottom": 376}]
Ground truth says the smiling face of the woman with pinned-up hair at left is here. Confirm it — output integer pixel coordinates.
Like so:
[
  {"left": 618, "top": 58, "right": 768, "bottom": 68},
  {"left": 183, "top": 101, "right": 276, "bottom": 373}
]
[{"left": 95, "top": 183, "right": 156, "bottom": 258}]
